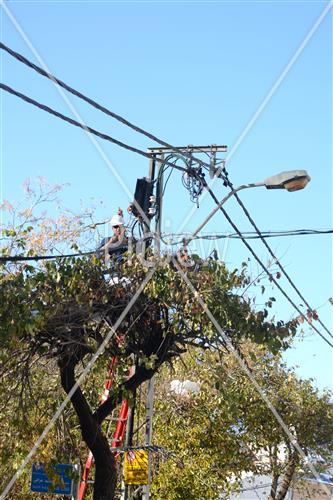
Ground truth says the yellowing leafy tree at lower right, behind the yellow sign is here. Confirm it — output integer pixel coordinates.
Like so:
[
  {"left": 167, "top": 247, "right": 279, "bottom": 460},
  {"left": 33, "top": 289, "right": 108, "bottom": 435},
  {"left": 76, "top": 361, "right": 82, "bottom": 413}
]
[{"left": 152, "top": 342, "right": 333, "bottom": 500}]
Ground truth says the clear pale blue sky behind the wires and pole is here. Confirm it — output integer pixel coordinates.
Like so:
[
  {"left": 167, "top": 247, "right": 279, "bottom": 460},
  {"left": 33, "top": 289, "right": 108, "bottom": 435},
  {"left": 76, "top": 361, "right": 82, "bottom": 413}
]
[{"left": 1, "top": 0, "right": 333, "bottom": 387}]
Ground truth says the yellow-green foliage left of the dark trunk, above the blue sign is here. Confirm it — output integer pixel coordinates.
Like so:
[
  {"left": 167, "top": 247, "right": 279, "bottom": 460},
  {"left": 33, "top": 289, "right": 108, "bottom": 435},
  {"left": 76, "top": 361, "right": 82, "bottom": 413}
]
[{"left": 0, "top": 362, "right": 84, "bottom": 500}]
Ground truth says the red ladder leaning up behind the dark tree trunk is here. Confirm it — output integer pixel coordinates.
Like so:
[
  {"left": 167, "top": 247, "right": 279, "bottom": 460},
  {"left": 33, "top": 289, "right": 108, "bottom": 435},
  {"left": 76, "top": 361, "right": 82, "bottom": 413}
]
[{"left": 78, "top": 356, "right": 128, "bottom": 500}]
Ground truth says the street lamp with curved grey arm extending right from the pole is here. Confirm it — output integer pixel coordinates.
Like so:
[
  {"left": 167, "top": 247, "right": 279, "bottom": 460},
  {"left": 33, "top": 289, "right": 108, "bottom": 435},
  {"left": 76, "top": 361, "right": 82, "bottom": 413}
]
[{"left": 186, "top": 170, "right": 311, "bottom": 243}]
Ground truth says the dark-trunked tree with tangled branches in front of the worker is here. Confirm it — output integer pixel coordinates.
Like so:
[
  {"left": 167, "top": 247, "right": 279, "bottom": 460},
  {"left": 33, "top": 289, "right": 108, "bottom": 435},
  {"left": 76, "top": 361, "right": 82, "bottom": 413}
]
[{"left": 0, "top": 183, "right": 296, "bottom": 500}]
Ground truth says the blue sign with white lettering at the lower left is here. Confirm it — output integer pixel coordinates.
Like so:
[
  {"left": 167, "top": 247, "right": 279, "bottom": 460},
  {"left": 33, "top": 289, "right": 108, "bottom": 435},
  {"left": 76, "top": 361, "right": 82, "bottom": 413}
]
[{"left": 30, "top": 464, "right": 73, "bottom": 495}]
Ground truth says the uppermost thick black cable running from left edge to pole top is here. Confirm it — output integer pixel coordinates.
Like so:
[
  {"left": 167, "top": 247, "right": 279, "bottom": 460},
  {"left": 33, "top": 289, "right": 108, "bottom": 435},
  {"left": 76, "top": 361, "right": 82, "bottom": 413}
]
[{"left": 0, "top": 43, "right": 218, "bottom": 176}]
